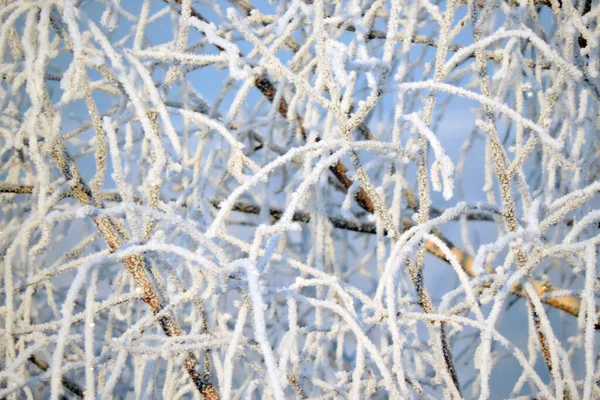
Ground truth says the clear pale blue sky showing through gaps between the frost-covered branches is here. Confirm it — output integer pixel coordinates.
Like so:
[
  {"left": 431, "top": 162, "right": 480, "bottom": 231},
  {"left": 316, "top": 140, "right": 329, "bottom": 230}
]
[{"left": 17, "top": 1, "right": 582, "bottom": 398}]
